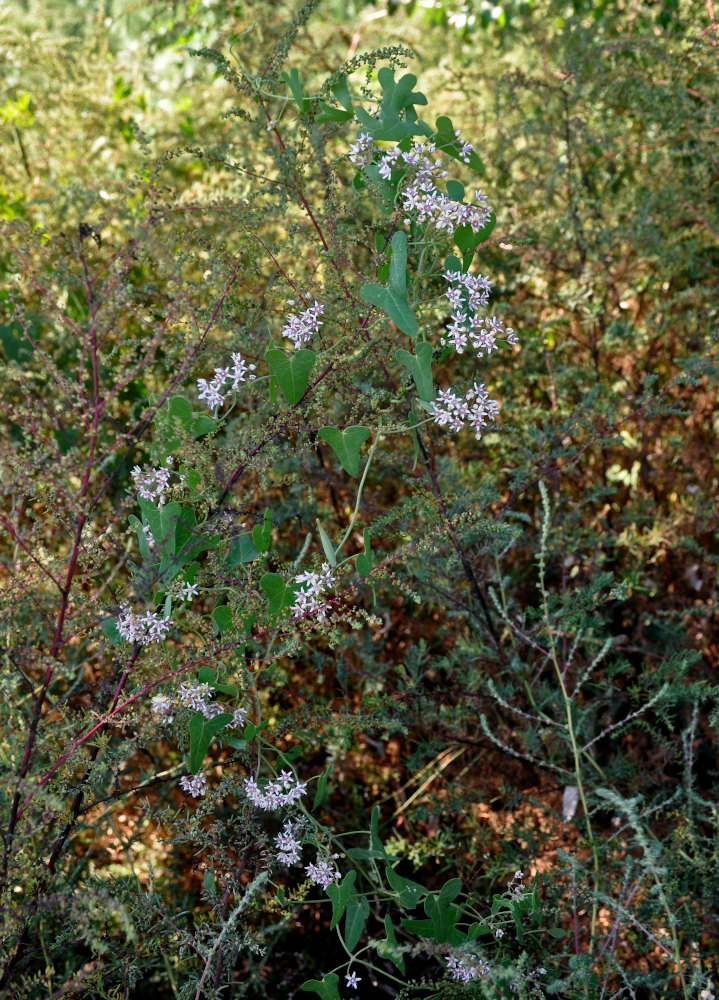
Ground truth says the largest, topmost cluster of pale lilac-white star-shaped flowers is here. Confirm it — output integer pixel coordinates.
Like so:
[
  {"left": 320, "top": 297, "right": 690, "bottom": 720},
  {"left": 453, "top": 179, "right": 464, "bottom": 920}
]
[{"left": 348, "top": 129, "right": 491, "bottom": 235}]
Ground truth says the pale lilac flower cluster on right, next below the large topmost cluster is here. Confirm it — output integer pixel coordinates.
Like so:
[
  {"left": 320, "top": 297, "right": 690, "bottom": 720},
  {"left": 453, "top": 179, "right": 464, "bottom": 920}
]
[{"left": 442, "top": 271, "right": 518, "bottom": 358}]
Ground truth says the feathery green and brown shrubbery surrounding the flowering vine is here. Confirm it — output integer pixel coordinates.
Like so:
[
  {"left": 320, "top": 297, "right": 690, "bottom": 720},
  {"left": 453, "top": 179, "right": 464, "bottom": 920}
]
[{"left": 0, "top": 0, "right": 719, "bottom": 998}]
